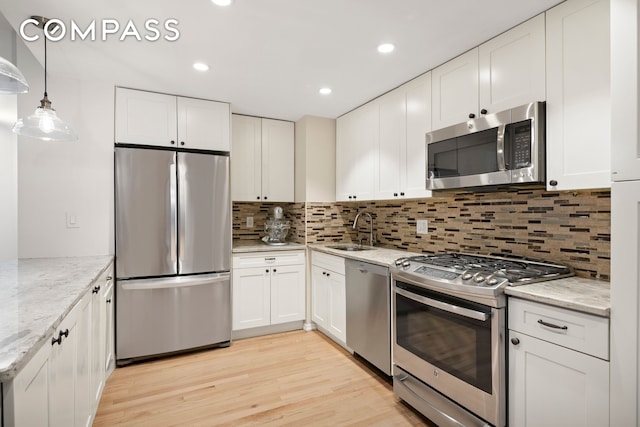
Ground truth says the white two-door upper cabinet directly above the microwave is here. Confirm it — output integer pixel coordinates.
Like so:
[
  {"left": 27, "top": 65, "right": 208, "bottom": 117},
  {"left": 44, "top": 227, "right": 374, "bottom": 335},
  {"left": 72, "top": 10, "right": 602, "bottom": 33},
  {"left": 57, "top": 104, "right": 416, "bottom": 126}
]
[{"left": 432, "top": 14, "right": 545, "bottom": 129}]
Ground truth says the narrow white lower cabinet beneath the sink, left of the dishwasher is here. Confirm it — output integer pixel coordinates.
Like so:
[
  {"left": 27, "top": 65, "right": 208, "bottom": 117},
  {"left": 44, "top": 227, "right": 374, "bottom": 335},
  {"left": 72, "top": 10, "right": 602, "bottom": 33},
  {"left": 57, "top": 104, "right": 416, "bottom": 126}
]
[{"left": 311, "top": 251, "right": 347, "bottom": 345}]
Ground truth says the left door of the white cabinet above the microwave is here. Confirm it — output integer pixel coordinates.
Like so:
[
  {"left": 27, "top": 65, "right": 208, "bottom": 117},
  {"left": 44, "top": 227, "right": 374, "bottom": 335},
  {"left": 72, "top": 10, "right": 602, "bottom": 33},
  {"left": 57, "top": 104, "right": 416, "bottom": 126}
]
[{"left": 431, "top": 48, "right": 478, "bottom": 129}]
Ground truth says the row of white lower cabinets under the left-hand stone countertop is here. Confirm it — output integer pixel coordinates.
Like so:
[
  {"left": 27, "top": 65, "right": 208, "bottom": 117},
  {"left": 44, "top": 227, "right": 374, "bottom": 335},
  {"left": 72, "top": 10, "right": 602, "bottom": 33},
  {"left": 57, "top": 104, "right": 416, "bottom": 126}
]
[{"left": 2, "top": 262, "right": 114, "bottom": 427}]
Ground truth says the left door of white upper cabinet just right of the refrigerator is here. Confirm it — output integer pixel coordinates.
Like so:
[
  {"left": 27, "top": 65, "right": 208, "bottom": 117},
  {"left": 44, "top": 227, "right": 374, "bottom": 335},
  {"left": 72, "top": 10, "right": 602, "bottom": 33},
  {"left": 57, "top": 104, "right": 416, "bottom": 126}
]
[{"left": 230, "top": 114, "right": 262, "bottom": 202}]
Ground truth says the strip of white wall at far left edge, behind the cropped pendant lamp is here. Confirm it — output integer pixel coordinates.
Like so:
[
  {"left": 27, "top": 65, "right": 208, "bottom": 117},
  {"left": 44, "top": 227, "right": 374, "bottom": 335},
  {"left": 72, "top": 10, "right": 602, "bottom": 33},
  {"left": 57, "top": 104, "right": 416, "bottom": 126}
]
[{"left": 0, "top": 14, "right": 18, "bottom": 261}]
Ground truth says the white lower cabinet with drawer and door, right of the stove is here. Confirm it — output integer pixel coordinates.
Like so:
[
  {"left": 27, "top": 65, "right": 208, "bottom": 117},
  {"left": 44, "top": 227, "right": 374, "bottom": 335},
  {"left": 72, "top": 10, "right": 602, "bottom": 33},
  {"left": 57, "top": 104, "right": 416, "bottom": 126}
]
[{"left": 508, "top": 299, "right": 609, "bottom": 427}]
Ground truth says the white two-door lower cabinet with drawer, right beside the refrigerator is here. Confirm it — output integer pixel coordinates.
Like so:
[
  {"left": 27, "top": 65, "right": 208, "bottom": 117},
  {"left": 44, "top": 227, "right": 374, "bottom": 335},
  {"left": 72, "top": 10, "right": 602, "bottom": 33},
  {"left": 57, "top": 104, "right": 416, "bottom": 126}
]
[{"left": 233, "top": 251, "right": 306, "bottom": 331}]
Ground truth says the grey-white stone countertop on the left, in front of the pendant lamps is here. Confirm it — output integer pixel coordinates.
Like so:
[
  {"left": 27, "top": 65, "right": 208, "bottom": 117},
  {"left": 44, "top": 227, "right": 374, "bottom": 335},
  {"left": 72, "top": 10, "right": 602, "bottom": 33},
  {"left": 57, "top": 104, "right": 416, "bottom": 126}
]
[{"left": 0, "top": 256, "right": 113, "bottom": 382}]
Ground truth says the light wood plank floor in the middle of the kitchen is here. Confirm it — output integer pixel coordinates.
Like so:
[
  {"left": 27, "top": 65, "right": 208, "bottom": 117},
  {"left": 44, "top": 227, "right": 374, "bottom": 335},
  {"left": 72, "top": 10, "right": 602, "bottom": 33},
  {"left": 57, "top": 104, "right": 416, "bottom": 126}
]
[{"left": 94, "top": 331, "right": 434, "bottom": 427}]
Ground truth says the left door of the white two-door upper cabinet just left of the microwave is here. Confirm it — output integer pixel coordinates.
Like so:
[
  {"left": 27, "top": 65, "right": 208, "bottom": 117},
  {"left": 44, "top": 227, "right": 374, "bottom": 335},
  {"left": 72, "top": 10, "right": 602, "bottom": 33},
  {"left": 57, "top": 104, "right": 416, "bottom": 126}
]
[{"left": 374, "top": 87, "right": 407, "bottom": 200}]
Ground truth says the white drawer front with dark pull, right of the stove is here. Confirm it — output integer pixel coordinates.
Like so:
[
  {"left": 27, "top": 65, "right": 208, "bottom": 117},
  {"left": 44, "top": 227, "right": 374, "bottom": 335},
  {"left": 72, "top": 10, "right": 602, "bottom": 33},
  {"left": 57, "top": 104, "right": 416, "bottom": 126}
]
[{"left": 509, "top": 298, "right": 609, "bottom": 360}]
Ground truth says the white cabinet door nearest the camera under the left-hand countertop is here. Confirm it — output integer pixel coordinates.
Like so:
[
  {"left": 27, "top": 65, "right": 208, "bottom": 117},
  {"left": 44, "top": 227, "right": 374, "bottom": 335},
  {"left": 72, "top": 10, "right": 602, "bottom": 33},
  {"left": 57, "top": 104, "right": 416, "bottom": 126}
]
[{"left": 9, "top": 341, "right": 53, "bottom": 426}]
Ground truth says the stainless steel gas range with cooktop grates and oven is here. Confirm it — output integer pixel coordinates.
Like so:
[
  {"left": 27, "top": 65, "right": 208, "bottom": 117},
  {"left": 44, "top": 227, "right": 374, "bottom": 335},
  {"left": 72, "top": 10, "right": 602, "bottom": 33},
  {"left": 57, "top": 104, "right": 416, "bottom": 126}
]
[{"left": 390, "top": 253, "right": 573, "bottom": 427}]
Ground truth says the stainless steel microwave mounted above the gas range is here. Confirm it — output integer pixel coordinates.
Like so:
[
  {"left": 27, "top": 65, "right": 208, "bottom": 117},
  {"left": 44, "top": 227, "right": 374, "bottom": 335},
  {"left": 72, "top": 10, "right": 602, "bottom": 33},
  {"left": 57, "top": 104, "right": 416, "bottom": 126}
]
[{"left": 426, "top": 102, "right": 545, "bottom": 190}]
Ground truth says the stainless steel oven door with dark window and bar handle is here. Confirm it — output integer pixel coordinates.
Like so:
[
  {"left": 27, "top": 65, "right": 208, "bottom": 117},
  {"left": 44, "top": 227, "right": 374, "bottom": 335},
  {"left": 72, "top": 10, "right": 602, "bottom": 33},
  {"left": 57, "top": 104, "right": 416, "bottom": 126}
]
[{"left": 393, "top": 280, "right": 506, "bottom": 425}]
